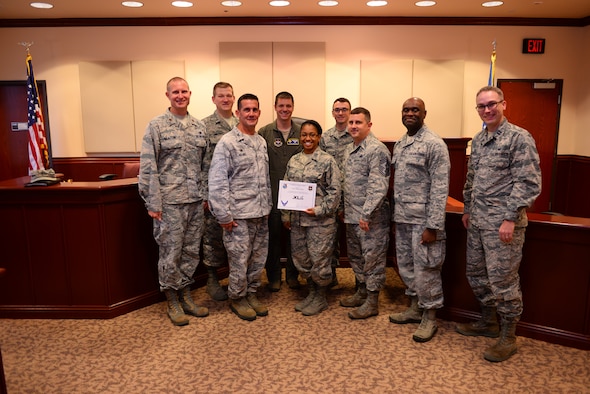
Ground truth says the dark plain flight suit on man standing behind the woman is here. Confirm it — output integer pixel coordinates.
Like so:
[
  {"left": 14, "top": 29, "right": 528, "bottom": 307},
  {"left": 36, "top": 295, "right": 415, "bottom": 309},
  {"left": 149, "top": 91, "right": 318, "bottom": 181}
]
[{"left": 258, "top": 121, "right": 302, "bottom": 282}]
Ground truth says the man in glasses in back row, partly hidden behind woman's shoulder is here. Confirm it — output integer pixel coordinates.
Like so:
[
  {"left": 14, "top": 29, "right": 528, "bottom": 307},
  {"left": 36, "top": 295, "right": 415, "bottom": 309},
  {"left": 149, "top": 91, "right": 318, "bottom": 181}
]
[{"left": 320, "top": 97, "right": 352, "bottom": 287}]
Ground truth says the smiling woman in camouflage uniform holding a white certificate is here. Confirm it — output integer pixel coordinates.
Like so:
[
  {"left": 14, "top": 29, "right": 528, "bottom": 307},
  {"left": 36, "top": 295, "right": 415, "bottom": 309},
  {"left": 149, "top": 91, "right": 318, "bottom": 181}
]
[{"left": 278, "top": 120, "right": 341, "bottom": 316}]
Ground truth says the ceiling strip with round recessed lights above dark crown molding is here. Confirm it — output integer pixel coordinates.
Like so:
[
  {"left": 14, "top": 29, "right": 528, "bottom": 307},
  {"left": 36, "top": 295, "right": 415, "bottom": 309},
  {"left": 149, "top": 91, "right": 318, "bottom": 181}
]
[{"left": 0, "top": 0, "right": 590, "bottom": 20}]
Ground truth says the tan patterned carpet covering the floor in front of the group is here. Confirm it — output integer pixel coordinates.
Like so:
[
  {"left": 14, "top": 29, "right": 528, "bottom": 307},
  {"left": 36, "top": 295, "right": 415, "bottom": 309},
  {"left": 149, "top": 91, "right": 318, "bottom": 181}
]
[{"left": 0, "top": 268, "right": 590, "bottom": 394}]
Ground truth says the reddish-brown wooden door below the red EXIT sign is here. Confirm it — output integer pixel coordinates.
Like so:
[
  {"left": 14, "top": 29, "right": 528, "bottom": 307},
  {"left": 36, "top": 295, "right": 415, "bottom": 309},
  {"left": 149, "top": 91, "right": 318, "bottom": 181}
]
[{"left": 498, "top": 79, "right": 563, "bottom": 212}]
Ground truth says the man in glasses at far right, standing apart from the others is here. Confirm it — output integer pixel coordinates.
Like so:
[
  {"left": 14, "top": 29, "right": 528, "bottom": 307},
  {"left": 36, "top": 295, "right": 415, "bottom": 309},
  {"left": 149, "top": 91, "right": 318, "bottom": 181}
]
[{"left": 456, "top": 86, "right": 541, "bottom": 362}]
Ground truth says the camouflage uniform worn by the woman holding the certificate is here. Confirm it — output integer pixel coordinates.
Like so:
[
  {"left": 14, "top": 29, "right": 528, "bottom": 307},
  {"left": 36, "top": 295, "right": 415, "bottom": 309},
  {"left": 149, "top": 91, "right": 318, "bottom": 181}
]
[{"left": 282, "top": 149, "right": 341, "bottom": 286}]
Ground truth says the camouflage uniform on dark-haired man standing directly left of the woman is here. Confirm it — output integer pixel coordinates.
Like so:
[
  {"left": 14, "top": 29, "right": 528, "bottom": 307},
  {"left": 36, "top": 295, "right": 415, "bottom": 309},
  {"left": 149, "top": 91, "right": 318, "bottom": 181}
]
[{"left": 209, "top": 127, "right": 272, "bottom": 299}]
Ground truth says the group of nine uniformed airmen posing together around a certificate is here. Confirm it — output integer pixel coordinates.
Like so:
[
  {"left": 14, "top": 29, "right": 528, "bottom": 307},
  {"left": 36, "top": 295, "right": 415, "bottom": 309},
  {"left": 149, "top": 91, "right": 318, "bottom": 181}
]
[{"left": 139, "top": 77, "right": 541, "bottom": 362}]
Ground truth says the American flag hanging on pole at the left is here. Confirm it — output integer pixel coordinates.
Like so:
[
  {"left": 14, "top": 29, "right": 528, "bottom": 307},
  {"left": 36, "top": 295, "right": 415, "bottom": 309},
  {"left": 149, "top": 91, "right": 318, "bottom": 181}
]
[{"left": 27, "top": 53, "right": 49, "bottom": 172}]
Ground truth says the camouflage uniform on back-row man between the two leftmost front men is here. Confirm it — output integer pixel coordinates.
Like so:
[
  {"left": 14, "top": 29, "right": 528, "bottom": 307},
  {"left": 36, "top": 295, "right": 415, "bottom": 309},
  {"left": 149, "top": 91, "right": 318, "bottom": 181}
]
[{"left": 203, "top": 111, "right": 238, "bottom": 268}]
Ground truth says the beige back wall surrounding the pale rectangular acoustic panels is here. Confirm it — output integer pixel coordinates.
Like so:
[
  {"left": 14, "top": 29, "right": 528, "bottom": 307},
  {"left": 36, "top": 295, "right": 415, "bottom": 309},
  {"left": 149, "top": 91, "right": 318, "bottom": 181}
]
[{"left": 0, "top": 26, "right": 590, "bottom": 157}]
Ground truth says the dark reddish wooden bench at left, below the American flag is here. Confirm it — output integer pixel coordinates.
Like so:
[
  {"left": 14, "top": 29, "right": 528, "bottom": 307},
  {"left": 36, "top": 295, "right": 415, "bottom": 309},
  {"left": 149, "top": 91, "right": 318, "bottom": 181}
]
[{"left": 0, "top": 177, "right": 162, "bottom": 318}]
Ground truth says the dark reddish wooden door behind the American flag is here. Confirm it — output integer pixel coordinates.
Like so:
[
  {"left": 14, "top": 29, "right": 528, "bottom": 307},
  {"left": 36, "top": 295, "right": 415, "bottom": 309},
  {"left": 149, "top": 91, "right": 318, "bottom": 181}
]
[{"left": 0, "top": 81, "right": 51, "bottom": 180}]
